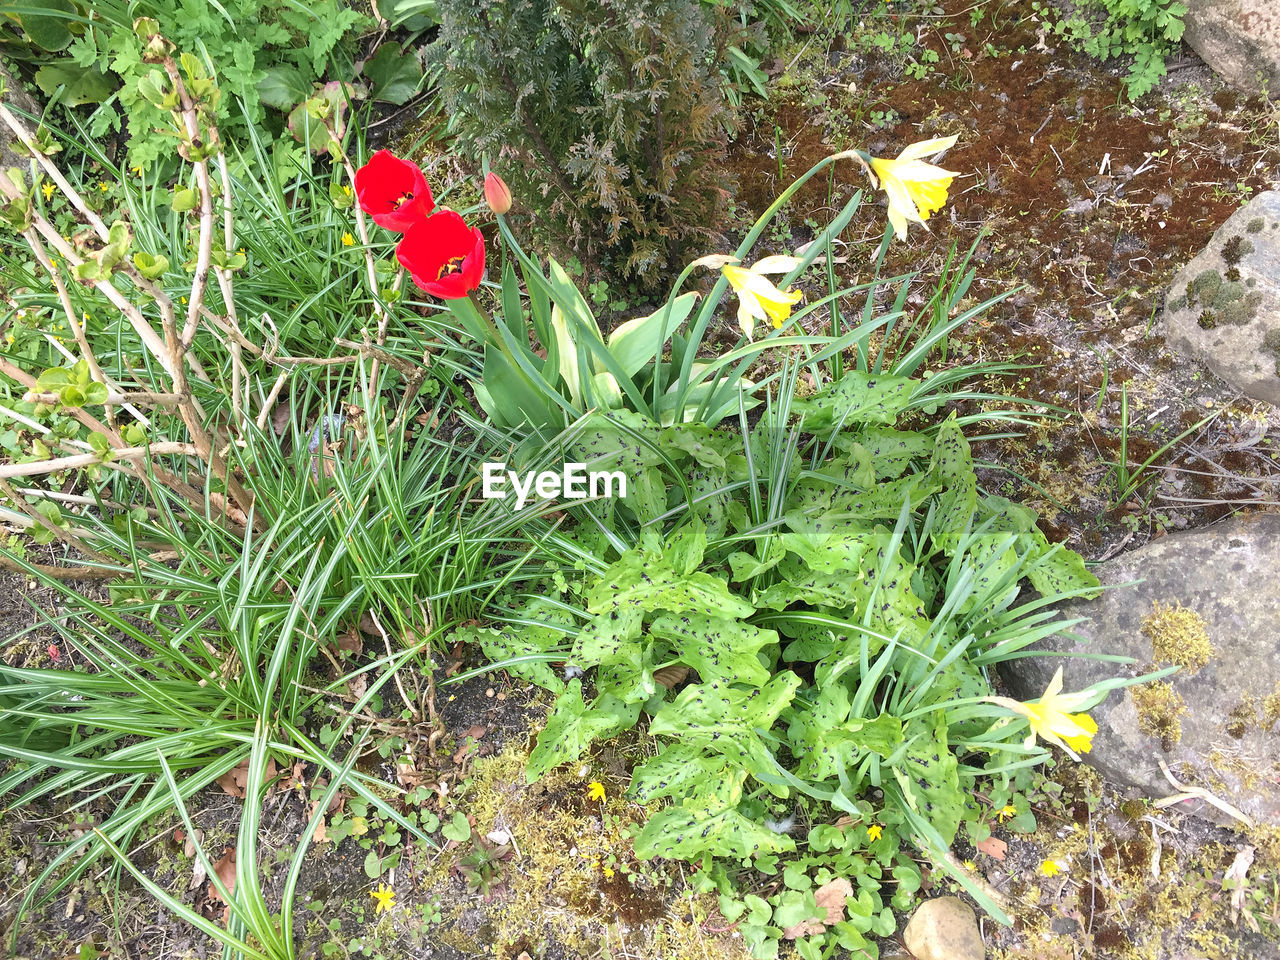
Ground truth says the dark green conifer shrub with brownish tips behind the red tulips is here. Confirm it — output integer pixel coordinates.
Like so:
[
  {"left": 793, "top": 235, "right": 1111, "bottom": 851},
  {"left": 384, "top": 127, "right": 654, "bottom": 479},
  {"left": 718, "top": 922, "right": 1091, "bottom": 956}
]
[{"left": 430, "top": 0, "right": 737, "bottom": 283}]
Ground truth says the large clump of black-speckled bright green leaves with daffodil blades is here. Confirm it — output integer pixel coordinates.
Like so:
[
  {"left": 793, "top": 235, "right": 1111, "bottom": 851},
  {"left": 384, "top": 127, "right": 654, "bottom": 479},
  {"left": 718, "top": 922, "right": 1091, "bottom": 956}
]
[{"left": 460, "top": 370, "right": 1152, "bottom": 956}]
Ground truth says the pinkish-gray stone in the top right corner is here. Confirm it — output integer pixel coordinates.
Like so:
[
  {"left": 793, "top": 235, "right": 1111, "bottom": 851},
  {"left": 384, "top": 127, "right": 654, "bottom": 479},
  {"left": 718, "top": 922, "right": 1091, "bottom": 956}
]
[{"left": 1183, "top": 0, "right": 1280, "bottom": 96}]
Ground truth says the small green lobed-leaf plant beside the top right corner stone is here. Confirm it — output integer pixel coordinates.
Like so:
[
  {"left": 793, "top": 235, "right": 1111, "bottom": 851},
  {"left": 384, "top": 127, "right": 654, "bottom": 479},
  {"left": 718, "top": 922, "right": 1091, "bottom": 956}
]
[{"left": 1033, "top": 0, "right": 1187, "bottom": 100}]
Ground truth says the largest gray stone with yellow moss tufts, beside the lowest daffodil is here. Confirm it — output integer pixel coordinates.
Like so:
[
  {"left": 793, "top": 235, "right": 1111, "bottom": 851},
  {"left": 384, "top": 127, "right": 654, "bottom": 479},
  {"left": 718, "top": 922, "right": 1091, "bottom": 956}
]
[{"left": 1001, "top": 513, "right": 1280, "bottom": 826}]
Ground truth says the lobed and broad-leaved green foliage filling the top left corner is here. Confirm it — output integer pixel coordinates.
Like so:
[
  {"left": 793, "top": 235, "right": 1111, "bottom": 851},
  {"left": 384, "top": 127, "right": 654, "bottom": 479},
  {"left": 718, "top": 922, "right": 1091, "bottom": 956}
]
[{"left": 3, "top": 0, "right": 373, "bottom": 168}]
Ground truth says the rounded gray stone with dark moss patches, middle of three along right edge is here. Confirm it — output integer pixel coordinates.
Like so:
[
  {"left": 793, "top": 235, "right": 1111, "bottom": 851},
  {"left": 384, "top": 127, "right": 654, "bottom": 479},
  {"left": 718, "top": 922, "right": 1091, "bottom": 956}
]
[{"left": 1164, "top": 191, "right": 1280, "bottom": 406}]
